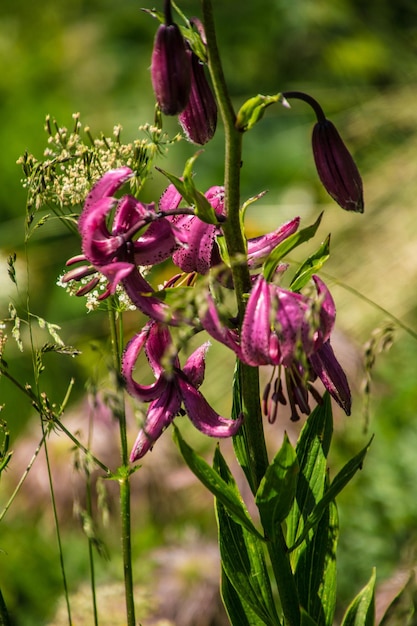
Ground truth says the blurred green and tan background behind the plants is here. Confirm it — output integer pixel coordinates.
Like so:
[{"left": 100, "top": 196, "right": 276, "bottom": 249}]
[{"left": 0, "top": 0, "right": 417, "bottom": 626}]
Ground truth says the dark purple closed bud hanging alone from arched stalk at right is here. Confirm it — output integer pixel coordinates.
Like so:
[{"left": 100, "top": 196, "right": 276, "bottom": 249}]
[{"left": 312, "top": 119, "right": 364, "bottom": 213}]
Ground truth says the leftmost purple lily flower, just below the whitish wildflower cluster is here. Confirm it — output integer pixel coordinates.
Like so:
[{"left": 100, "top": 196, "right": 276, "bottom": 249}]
[{"left": 62, "top": 167, "right": 178, "bottom": 320}]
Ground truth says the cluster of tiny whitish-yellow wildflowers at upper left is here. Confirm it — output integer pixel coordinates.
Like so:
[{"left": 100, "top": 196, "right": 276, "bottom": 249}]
[{"left": 18, "top": 113, "right": 178, "bottom": 225}]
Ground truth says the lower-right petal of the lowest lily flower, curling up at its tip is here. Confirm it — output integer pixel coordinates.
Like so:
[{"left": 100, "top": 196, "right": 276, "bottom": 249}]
[{"left": 178, "top": 378, "right": 243, "bottom": 438}]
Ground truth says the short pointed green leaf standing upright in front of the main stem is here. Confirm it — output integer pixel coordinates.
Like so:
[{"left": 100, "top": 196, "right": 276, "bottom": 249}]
[{"left": 256, "top": 434, "right": 299, "bottom": 538}]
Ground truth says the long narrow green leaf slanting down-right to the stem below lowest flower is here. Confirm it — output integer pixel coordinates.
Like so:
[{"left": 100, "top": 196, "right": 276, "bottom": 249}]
[{"left": 173, "top": 424, "right": 264, "bottom": 541}]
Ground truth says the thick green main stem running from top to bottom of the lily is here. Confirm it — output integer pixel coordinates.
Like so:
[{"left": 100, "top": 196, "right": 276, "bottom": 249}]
[{"left": 202, "top": 0, "right": 300, "bottom": 626}]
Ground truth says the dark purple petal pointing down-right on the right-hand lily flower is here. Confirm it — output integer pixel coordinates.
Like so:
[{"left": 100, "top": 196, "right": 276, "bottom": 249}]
[{"left": 310, "top": 341, "right": 352, "bottom": 415}]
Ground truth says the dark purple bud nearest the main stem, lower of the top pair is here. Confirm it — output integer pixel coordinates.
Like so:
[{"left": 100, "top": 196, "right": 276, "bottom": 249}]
[{"left": 178, "top": 50, "right": 217, "bottom": 145}]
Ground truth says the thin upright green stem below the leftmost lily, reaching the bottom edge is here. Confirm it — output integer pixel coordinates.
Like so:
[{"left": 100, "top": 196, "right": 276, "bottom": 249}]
[{"left": 109, "top": 307, "right": 136, "bottom": 626}]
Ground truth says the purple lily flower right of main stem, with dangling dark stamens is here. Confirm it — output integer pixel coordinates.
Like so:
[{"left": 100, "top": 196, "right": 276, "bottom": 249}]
[{"left": 240, "top": 275, "right": 351, "bottom": 421}]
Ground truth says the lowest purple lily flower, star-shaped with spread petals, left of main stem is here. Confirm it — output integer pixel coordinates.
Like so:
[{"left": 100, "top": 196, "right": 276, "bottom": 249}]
[{"left": 122, "top": 321, "right": 242, "bottom": 463}]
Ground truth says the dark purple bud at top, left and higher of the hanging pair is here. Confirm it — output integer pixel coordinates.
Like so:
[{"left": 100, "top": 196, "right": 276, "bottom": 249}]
[{"left": 151, "top": 23, "right": 191, "bottom": 115}]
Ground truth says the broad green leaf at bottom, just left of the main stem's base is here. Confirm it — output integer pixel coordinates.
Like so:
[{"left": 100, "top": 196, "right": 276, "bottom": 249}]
[{"left": 214, "top": 449, "right": 280, "bottom": 626}]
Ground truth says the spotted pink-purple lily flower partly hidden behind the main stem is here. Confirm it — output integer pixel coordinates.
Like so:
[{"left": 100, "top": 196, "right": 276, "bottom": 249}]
[{"left": 159, "top": 185, "right": 300, "bottom": 275}]
